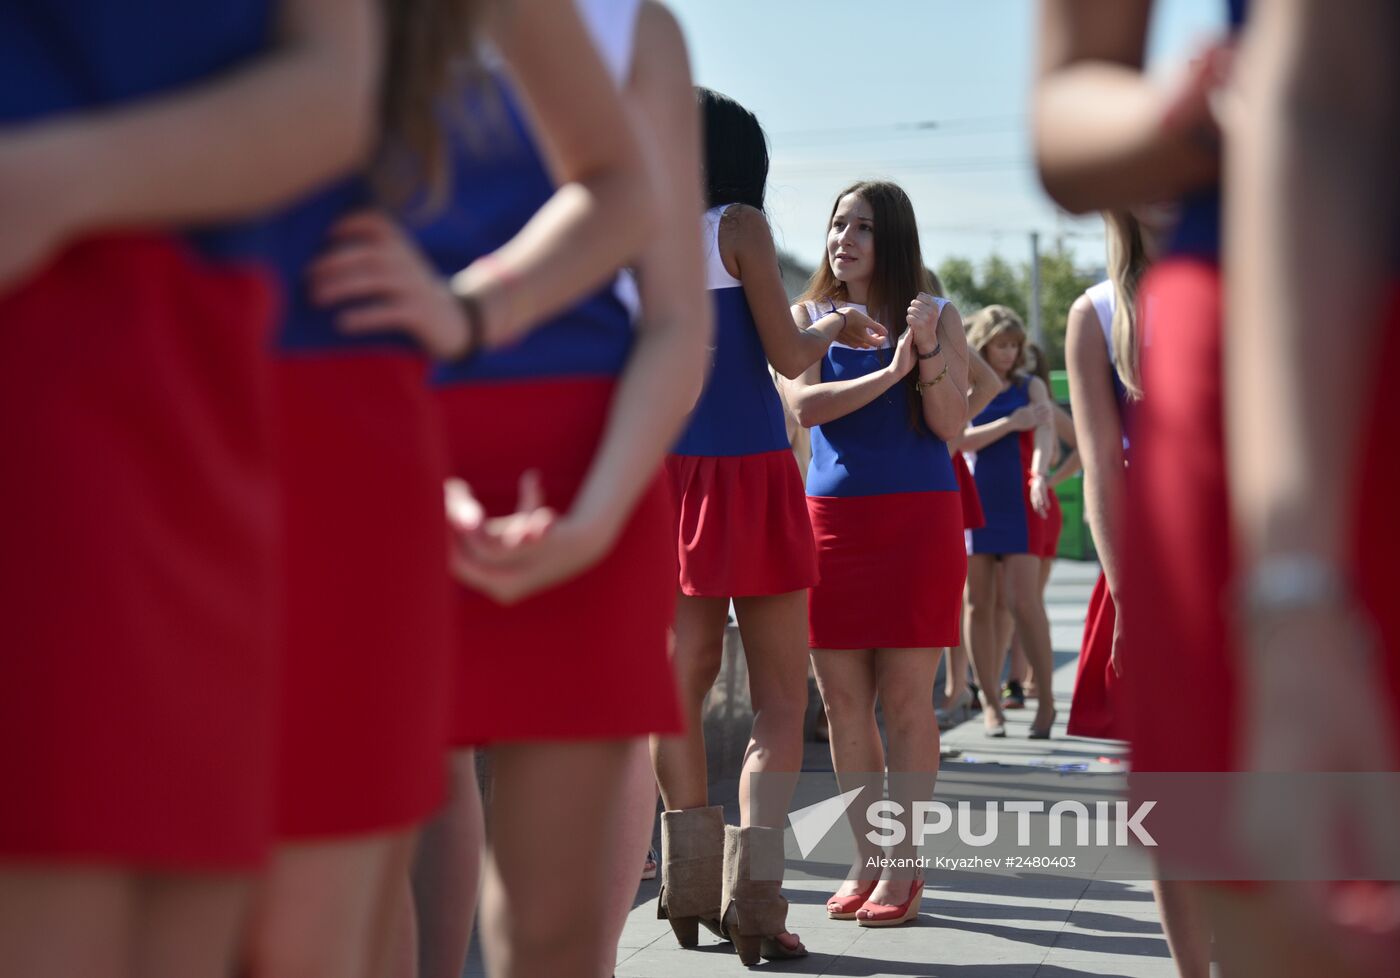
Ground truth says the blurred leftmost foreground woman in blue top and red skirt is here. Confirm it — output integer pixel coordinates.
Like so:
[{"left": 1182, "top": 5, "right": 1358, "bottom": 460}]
[{"left": 0, "top": 0, "right": 378, "bottom": 978}]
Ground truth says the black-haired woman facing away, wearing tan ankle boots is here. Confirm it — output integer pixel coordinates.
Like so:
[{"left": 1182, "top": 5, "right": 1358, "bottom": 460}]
[{"left": 652, "top": 88, "right": 882, "bottom": 957}]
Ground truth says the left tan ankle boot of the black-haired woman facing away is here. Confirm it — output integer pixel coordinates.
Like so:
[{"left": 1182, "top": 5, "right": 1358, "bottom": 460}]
[{"left": 657, "top": 806, "right": 724, "bottom": 947}]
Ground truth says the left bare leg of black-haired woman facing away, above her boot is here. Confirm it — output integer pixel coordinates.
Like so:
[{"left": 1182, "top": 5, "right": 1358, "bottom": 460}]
[{"left": 651, "top": 595, "right": 729, "bottom": 810}]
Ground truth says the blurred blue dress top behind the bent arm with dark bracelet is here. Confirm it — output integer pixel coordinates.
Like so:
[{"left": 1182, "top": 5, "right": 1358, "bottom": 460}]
[{"left": 403, "top": 78, "right": 633, "bottom": 383}]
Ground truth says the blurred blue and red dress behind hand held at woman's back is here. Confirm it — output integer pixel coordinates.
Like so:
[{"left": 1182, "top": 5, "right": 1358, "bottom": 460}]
[{"left": 417, "top": 4, "right": 683, "bottom": 744}]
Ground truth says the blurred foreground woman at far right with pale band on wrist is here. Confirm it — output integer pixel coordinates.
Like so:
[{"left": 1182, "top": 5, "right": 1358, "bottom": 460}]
[{"left": 1037, "top": 0, "right": 1400, "bottom": 975}]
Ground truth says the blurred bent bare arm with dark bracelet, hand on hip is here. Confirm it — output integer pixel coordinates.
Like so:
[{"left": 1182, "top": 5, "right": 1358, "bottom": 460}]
[{"left": 311, "top": 0, "right": 658, "bottom": 360}]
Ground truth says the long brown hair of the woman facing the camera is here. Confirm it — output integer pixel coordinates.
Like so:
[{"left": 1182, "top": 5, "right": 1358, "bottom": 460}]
[{"left": 798, "top": 180, "right": 942, "bottom": 430}]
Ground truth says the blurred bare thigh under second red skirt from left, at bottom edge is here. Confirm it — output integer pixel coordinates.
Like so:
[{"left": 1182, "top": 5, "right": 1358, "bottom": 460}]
[{"left": 245, "top": 832, "right": 412, "bottom": 978}]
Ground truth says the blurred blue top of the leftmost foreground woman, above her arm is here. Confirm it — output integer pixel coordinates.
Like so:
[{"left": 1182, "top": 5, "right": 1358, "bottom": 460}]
[{"left": 0, "top": 0, "right": 274, "bottom": 264}]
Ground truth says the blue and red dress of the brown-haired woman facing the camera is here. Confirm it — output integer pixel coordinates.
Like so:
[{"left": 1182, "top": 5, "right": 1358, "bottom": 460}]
[{"left": 806, "top": 299, "right": 967, "bottom": 649}]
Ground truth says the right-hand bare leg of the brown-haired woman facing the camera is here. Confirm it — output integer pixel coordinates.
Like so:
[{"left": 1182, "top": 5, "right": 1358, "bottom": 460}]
[{"left": 871, "top": 649, "right": 941, "bottom": 904}]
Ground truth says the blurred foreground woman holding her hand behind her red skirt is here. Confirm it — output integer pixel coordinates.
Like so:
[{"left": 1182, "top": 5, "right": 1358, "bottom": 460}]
[{"left": 305, "top": 3, "right": 708, "bottom": 975}]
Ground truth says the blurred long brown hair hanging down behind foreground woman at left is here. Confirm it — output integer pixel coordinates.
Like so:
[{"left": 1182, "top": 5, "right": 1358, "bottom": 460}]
[{"left": 374, "top": 0, "right": 501, "bottom": 210}]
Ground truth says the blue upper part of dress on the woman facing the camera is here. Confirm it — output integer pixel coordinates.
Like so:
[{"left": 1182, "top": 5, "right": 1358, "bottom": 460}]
[{"left": 806, "top": 304, "right": 958, "bottom": 497}]
